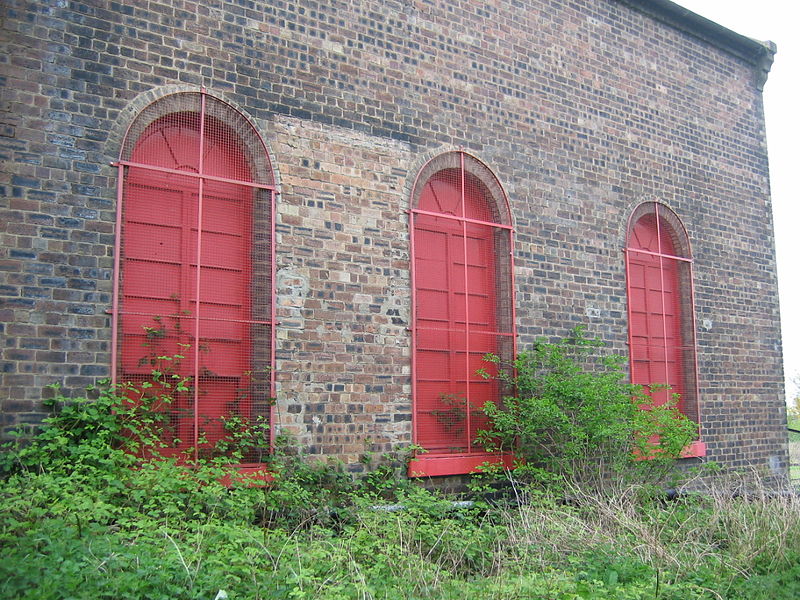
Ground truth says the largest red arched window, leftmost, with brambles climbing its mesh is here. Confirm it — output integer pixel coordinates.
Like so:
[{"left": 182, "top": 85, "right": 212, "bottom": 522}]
[{"left": 112, "top": 92, "right": 275, "bottom": 462}]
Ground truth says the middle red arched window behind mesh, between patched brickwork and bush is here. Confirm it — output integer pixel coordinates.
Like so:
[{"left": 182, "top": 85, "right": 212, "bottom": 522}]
[{"left": 409, "top": 152, "right": 514, "bottom": 475}]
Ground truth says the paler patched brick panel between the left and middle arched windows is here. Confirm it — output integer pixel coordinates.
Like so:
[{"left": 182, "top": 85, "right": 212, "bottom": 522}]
[{"left": 271, "top": 118, "right": 414, "bottom": 468}]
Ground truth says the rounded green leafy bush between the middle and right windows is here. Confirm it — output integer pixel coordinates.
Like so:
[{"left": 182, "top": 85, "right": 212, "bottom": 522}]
[{"left": 481, "top": 328, "right": 697, "bottom": 488}]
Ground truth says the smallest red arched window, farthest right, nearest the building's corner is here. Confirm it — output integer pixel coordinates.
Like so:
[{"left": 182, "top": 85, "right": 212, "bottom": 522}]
[{"left": 626, "top": 202, "right": 702, "bottom": 455}]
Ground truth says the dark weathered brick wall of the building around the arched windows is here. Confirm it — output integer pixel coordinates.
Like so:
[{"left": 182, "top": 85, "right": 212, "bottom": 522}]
[{"left": 0, "top": 0, "right": 786, "bottom": 470}]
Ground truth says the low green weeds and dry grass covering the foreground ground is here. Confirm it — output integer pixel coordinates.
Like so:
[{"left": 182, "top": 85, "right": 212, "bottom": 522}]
[{"left": 0, "top": 464, "right": 800, "bottom": 600}]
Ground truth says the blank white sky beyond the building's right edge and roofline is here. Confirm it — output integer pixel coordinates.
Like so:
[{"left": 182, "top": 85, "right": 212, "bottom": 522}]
[{"left": 674, "top": 0, "right": 800, "bottom": 398}]
